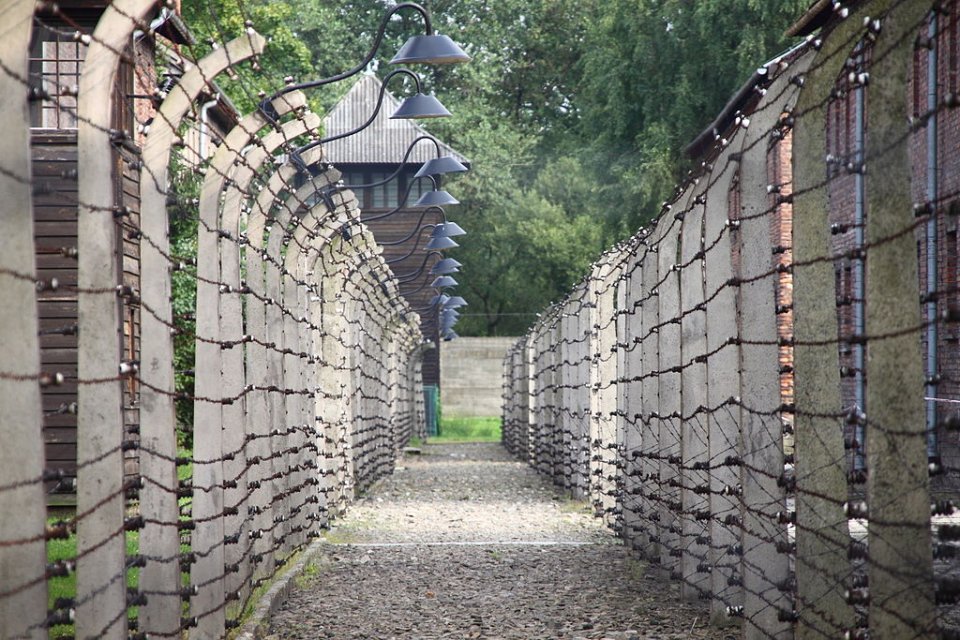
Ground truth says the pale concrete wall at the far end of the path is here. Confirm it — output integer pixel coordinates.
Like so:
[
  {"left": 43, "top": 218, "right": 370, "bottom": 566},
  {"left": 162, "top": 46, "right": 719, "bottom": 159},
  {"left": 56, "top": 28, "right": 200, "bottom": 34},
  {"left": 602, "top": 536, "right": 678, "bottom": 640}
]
[{"left": 440, "top": 338, "right": 517, "bottom": 416}]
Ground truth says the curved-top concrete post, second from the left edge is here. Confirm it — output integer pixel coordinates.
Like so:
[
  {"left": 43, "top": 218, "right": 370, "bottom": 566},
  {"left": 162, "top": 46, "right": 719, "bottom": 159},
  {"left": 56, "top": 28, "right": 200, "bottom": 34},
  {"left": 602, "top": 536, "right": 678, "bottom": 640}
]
[{"left": 76, "top": 0, "right": 156, "bottom": 639}]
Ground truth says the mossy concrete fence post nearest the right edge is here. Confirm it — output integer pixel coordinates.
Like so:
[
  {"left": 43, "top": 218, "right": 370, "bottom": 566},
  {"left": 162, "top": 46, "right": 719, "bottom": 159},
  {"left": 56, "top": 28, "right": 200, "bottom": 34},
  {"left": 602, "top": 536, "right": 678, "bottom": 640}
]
[{"left": 863, "top": 2, "right": 932, "bottom": 638}]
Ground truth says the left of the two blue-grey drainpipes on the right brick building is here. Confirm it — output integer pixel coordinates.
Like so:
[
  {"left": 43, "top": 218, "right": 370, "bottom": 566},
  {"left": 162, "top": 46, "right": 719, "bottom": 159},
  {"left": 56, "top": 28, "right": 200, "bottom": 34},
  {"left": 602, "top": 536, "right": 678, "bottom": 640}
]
[{"left": 853, "top": 58, "right": 867, "bottom": 471}]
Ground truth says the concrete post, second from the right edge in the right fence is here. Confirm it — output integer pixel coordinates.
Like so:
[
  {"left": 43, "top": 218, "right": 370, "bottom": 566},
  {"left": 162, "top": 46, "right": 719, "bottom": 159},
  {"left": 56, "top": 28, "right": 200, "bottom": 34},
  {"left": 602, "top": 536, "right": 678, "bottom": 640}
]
[{"left": 792, "top": 38, "right": 854, "bottom": 640}]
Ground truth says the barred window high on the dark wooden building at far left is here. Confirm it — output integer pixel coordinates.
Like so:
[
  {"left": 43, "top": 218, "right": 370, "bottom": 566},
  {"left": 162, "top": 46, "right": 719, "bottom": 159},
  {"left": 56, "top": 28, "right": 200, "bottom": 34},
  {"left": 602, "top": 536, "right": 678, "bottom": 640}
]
[{"left": 30, "top": 23, "right": 87, "bottom": 129}]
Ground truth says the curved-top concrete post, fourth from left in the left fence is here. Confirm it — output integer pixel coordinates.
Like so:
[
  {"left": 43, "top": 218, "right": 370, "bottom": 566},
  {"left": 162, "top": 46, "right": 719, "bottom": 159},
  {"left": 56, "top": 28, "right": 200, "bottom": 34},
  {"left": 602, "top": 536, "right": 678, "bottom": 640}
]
[{"left": 191, "top": 101, "right": 319, "bottom": 637}]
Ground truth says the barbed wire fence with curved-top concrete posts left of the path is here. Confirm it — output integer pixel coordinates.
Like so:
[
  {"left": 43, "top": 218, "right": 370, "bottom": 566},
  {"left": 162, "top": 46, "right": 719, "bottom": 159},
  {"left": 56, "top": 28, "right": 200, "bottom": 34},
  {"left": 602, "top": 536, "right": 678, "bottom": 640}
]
[{"left": 0, "top": 0, "right": 423, "bottom": 638}]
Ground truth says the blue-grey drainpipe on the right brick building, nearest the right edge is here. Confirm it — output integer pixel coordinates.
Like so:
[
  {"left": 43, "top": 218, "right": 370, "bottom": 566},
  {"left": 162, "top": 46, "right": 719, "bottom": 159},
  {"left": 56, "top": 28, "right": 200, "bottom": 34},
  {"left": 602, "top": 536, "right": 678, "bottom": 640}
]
[{"left": 925, "top": 11, "right": 939, "bottom": 462}]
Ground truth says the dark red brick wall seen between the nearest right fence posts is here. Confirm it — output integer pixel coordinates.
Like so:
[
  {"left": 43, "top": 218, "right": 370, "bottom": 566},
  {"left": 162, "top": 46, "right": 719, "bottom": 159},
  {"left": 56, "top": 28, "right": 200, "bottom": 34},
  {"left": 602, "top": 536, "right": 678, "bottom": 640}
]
[{"left": 825, "top": 0, "right": 960, "bottom": 478}]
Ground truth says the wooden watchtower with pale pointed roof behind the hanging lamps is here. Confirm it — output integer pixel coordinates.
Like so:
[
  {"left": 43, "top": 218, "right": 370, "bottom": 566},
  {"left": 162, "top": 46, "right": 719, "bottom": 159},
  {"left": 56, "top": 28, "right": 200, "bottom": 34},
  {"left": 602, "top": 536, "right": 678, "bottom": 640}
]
[{"left": 324, "top": 75, "right": 469, "bottom": 385}]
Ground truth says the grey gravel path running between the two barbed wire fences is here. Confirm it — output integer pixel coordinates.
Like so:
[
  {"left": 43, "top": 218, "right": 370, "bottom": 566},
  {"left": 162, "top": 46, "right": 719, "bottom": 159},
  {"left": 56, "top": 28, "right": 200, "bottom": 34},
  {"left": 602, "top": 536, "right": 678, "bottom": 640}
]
[{"left": 271, "top": 444, "right": 737, "bottom": 640}]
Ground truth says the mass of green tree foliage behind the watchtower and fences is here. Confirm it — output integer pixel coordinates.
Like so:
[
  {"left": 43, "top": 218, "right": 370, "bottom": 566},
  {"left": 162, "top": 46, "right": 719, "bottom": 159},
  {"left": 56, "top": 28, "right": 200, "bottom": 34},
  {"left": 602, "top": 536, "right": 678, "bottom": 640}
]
[{"left": 178, "top": 0, "right": 810, "bottom": 335}]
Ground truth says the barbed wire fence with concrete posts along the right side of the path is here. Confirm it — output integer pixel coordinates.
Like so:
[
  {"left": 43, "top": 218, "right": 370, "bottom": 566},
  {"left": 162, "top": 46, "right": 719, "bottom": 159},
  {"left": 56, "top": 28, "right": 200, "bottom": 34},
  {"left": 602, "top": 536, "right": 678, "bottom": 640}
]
[{"left": 504, "top": 0, "right": 960, "bottom": 638}]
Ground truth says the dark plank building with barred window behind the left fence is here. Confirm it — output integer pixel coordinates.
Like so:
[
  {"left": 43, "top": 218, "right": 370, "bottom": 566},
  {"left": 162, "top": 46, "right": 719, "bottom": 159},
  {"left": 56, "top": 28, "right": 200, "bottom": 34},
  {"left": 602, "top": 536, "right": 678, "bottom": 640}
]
[{"left": 29, "top": 0, "right": 236, "bottom": 504}]
